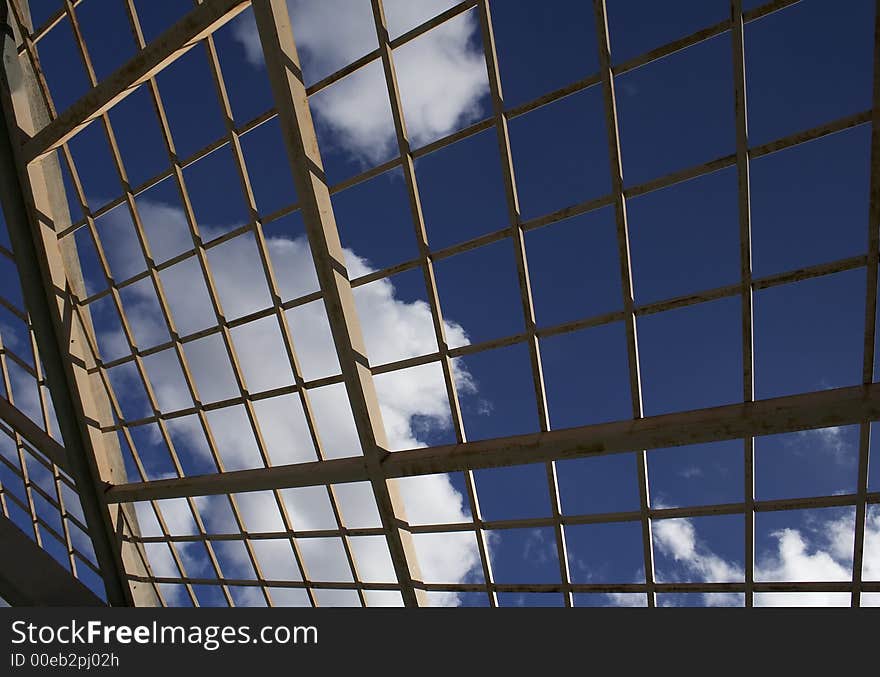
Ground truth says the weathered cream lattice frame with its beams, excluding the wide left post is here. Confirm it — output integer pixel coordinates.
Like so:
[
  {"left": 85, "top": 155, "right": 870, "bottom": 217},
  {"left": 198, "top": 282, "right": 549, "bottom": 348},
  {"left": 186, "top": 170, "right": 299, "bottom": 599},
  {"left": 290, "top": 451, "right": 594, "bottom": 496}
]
[{"left": 0, "top": 0, "right": 880, "bottom": 606}]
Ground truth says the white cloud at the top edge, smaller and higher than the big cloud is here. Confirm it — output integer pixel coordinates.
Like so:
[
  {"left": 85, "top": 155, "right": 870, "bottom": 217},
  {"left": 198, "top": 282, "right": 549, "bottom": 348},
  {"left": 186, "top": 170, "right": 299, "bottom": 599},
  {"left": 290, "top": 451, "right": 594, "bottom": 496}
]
[{"left": 233, "top": 0, "right": 489, "bottom": 165}]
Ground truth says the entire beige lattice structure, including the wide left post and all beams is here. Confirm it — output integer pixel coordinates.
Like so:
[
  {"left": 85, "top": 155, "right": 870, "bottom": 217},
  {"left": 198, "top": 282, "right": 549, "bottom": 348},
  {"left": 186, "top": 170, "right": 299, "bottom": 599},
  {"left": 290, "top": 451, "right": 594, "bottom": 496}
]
[{"left": 0, "top": 0, "right": 880, "bottom": 606}]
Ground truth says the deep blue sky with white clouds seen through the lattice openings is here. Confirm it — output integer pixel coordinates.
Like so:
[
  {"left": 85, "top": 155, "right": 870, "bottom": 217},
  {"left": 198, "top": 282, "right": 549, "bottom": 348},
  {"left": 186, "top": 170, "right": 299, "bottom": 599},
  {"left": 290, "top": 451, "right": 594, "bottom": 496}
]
[{"left": 0, "top": 0, "right": 880, "bottom": 606}]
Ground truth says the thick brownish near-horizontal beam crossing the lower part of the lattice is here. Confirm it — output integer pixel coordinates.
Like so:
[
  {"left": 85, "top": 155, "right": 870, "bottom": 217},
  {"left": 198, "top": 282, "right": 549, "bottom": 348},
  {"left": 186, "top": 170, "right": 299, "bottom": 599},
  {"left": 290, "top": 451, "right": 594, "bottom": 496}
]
[{"left": 106, "top": 383, "right": 880, "bottom": 503}]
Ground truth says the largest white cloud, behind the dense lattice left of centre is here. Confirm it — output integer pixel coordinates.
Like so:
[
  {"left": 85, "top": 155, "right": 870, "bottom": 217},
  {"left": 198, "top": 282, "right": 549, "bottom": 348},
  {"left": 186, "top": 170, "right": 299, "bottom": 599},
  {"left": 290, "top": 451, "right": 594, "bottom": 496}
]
[{"left": 96, "top": 201, "right": 479, "bottom": 604}]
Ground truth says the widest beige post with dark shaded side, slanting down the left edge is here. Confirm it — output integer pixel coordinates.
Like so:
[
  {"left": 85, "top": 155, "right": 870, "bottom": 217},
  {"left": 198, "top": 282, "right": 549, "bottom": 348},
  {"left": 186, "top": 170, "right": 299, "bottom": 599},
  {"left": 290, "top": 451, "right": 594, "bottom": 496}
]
[{"left": 0, "top": 2, "right": 158, "bottom": 606}]
